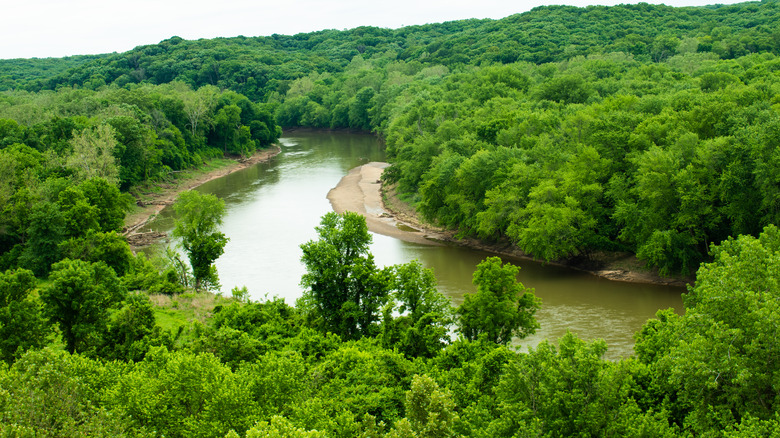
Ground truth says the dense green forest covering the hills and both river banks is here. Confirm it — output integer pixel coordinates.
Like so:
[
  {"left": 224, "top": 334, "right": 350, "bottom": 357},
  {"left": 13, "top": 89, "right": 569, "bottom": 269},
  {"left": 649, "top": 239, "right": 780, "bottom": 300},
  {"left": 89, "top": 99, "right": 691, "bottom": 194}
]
[{"left": 0, "top": 0, "right": 780, "bottom": 437}]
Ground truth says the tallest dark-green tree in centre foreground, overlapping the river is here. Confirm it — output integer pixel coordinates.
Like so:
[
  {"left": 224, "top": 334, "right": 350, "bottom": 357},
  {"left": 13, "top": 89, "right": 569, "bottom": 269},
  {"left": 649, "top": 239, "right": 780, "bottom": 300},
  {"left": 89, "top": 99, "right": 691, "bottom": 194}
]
[{"left": 301, "top": 212, "right": 388, "bottom": 339}]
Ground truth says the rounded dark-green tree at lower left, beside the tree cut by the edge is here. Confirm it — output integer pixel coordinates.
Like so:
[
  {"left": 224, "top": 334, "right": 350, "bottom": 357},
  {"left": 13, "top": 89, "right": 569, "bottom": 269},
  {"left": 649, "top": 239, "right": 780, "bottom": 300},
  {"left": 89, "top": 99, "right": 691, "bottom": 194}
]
[{"left": 41, "top": 259, "right": 127, "bottom": 354}]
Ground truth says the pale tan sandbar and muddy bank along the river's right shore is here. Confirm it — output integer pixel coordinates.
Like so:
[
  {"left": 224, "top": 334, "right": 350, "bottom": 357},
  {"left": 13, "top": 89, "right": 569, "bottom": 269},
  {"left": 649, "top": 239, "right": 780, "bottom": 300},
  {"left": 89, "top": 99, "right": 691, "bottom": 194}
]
[{"left": 328, "top": 162, "right": 693, "bottom": 286}]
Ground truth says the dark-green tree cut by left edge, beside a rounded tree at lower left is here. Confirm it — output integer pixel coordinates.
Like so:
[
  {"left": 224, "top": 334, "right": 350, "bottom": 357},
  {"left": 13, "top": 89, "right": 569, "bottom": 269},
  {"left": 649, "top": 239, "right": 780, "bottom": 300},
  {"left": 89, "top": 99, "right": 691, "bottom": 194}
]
[{"left": 0, "top": 269, "right": 47, "bottom": 362}]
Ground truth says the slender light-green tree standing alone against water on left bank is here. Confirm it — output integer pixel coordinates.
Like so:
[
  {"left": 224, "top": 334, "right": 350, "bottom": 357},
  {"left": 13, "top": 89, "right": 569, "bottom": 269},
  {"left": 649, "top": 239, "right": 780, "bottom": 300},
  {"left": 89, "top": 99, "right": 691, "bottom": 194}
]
[{"left": 173, "top": 190, "right": 228, "bottom": 290}]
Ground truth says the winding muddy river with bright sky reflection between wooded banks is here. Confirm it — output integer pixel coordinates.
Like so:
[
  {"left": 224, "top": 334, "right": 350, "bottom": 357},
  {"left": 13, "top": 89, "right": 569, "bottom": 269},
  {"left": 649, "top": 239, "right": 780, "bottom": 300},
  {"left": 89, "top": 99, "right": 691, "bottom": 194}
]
[{"left": 140, "top": 131, "right": 685, "bottom": 359}]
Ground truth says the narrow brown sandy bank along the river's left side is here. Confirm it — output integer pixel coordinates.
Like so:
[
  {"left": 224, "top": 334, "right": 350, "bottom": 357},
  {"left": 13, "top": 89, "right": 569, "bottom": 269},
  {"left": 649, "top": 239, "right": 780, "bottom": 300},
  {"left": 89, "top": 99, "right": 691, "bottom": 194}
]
[{"left": 123, "top": 146, "right": 281, "bottom": 247}]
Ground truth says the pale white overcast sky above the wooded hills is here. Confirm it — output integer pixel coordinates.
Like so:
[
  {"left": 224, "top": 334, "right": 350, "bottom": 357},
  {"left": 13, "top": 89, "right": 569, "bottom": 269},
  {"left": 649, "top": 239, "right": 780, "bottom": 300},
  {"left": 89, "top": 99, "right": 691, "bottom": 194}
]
[{"left": 0, "top": 0, "right": 735, "bottom": 59}]
